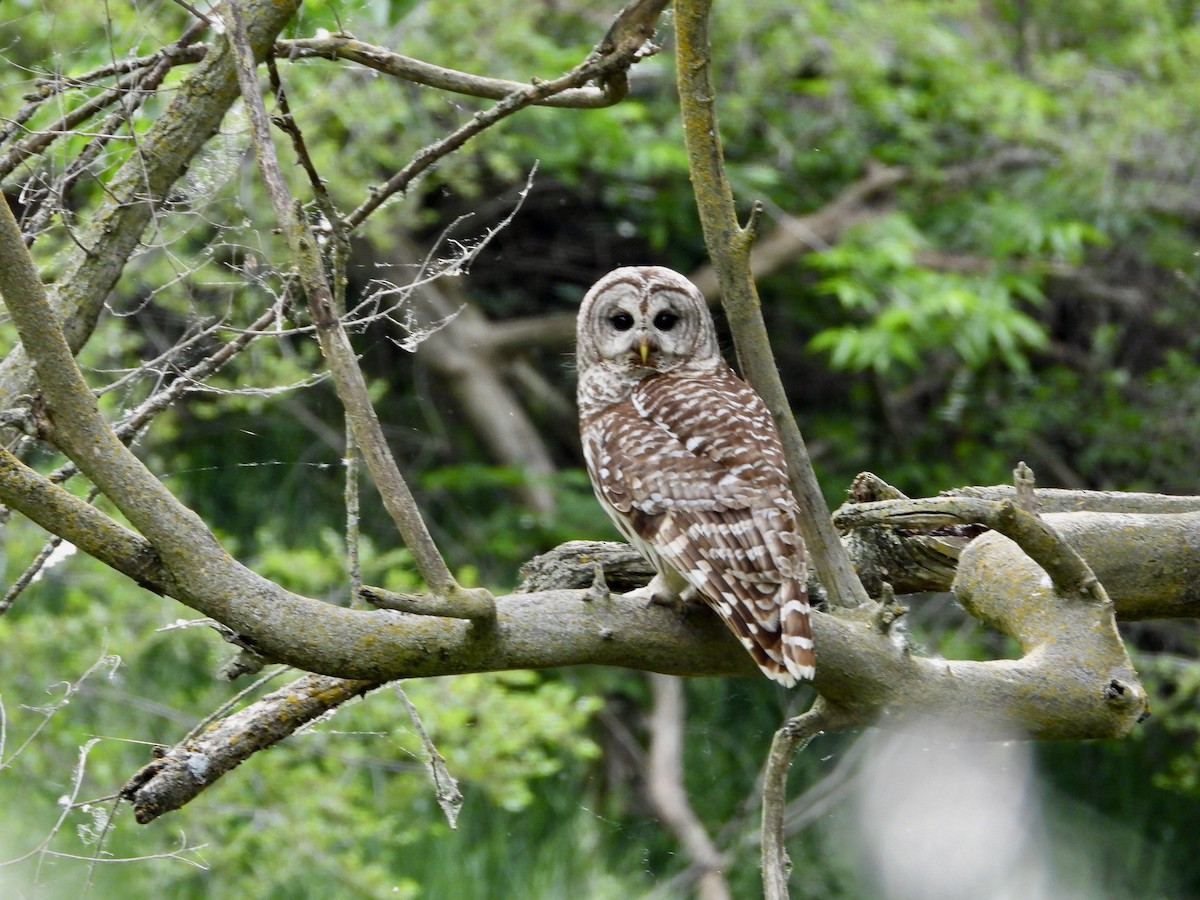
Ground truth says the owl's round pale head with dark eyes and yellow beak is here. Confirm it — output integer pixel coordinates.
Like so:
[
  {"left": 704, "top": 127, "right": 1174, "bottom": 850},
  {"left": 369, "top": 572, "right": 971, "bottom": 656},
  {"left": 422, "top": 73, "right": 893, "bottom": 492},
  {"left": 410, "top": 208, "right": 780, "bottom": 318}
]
[{"left": 576, "top": 265, "right": 721, "bottom": 374}]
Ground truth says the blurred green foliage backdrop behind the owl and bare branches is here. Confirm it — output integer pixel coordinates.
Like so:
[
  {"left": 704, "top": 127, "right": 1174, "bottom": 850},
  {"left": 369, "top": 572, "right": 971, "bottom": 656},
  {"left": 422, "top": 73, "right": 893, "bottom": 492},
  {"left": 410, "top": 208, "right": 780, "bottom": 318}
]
[{"left": 0, "top": 0, "right": 1200, "bottom": 898}]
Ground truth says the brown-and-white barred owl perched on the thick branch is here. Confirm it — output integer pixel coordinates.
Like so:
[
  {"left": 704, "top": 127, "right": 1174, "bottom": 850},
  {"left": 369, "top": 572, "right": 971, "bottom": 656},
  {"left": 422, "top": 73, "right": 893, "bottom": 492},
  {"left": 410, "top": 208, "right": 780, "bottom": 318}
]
[{"left": 576, "top": 266, "right": 815, "bottom": 688}]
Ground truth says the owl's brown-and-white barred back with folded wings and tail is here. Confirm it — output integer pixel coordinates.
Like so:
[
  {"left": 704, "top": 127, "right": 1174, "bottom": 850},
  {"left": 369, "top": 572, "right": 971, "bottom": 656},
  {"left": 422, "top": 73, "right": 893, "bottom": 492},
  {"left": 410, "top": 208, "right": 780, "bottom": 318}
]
[{"left": 587, "top": 372, "right": 814, "bottom": 686}]
